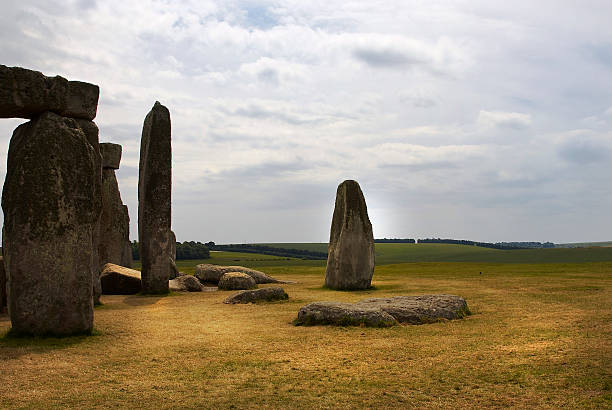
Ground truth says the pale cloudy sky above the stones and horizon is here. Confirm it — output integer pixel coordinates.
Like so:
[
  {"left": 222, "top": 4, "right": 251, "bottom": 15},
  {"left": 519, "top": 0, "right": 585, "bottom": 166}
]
[{"left": 0, "top": 0, "right": 612, "bottom": 243}]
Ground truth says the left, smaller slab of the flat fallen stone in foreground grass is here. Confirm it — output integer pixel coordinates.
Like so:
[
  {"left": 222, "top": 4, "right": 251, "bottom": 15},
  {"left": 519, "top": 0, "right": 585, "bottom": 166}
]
[{"left": 293, "top": 302, "right": 397, "bottom": 327}]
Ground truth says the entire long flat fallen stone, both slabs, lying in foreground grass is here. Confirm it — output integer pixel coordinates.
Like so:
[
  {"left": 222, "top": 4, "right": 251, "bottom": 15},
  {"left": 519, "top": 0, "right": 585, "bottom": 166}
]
[{"left": 294, "top": 295, "right": 470, "bottom": 326}]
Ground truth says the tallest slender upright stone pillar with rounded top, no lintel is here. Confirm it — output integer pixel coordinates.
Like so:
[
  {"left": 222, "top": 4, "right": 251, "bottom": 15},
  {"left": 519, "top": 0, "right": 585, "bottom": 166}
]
[{"left": 138, "top": 102, "right": 172, "bottom": 293}]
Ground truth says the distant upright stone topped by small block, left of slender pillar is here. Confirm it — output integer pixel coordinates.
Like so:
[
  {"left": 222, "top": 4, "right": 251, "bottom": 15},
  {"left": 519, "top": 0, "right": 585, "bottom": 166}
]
[{"left": 98, "top": 143, "right": 132, "bottom": 268}]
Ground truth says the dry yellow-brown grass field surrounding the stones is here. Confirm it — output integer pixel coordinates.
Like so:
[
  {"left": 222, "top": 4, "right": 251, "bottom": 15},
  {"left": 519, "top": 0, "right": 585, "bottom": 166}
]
[{"left": 0, "top": 244, "right": 612, "bottom": 409}]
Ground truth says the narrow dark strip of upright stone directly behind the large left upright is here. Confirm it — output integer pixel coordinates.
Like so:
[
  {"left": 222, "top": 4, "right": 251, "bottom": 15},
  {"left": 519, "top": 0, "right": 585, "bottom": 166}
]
[{"left": 75, "top": 119, "right": 102, "bottom": 305}]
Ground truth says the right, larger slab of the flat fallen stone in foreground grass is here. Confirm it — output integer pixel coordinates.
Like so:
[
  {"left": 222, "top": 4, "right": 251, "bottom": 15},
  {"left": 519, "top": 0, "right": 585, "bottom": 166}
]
[{"left": 356, "top": 295, "right": 469, "bottom": 325}]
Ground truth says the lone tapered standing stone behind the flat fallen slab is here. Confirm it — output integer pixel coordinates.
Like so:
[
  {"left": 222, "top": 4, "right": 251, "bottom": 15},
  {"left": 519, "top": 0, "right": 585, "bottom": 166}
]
[{"left": 325, "top": 180, "right": 374, "bottom": 290}]
